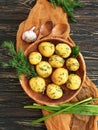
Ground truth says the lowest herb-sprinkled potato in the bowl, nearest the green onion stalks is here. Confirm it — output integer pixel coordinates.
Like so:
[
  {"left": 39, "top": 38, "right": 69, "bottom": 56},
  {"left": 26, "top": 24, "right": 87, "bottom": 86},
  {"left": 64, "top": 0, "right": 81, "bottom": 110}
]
[{"left": 46, "top": 83, "right": 63, "bottom": 99}]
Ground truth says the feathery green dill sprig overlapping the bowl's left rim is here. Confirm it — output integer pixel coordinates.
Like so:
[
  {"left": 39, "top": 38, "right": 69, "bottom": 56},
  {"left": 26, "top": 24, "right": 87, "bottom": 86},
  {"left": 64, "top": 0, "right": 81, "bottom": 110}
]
[{"left": 2, "top": 41, "right": 37, "bottom": 78}]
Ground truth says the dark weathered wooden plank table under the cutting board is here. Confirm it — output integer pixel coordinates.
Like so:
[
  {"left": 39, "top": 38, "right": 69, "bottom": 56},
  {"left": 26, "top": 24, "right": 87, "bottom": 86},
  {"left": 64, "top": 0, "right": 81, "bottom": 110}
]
[{"left": 0, "top": 0, "right": 98, "bottom": 130}]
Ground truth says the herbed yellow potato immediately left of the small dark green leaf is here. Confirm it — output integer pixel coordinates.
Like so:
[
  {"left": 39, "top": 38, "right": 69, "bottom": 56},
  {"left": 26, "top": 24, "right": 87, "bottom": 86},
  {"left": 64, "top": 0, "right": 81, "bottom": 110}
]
[{"left": 55, "top": 43, "right": 71, "bottom": 58}]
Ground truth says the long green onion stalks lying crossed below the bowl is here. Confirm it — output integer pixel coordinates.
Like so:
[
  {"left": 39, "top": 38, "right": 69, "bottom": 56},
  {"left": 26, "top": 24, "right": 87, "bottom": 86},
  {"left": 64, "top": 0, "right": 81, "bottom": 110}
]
[{"left": 24, "top": 97, "right": 98, "bottom": 125}]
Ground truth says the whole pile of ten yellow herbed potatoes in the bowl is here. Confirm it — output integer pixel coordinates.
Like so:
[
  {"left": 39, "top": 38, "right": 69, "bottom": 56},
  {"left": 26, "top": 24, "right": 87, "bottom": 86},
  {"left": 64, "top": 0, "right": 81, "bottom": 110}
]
[{"left": 28, "top": 42, "right": 81, "bottom": 99}]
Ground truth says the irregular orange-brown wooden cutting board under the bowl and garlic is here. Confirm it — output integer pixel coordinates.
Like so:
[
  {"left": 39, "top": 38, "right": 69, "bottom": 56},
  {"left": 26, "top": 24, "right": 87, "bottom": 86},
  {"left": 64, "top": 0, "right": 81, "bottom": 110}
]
[{"left": 16, "top": 0, "right": 98, "bottom": 130}]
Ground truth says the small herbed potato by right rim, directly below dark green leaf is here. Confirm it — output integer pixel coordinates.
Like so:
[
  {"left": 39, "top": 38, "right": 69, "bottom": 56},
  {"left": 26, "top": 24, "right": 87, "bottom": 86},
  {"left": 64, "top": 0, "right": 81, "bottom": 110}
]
[{"left": 66, "top": 57, "right": 79, "bottom": 71}]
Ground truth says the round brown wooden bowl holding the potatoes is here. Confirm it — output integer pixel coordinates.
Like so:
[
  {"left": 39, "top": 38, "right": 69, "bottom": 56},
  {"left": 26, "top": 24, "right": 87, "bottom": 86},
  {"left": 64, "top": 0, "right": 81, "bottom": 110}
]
[{"left": 20, "top": 38, "right": 86, "bottom": 105}]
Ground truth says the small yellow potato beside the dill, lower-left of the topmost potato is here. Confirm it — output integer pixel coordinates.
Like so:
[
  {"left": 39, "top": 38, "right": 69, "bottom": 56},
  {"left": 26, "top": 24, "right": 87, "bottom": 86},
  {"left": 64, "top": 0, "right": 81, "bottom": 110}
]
[{"left": 29, "top": 52, "right": 42, "bottom": 65}]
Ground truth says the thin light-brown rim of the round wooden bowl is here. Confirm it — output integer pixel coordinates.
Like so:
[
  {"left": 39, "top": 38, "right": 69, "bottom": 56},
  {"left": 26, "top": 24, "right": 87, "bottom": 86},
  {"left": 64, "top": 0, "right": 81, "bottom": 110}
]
[{"left": 20, "top": 38, "right": 86, "bottom": 105}]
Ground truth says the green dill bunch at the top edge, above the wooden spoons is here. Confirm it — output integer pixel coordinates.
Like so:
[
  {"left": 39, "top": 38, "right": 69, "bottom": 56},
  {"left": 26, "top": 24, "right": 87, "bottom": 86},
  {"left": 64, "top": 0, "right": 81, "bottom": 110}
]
[{"left": 49, "top": 0, "right": 82, "bottom": 22}]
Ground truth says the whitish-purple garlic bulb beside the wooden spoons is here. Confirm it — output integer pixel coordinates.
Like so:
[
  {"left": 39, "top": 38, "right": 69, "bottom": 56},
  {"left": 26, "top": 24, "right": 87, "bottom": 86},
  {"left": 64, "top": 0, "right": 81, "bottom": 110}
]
[{"left": 22, "top": 26, "right": 37, "bottom": 43}]
